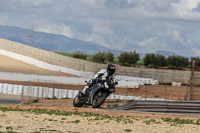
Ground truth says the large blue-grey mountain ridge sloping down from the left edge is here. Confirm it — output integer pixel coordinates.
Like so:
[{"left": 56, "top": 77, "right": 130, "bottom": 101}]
[{"left": 0, "top": 26, "right": 122, "bottom": 56}]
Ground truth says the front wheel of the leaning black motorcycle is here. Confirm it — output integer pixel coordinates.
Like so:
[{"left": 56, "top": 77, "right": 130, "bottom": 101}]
[{"left": 92, "top": 91, "right": 107, "bottom": 108}]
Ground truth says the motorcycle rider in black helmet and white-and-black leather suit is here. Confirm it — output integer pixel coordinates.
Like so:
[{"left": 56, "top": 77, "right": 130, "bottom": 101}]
[{"left": 82, "top": 64, "right": 117, "bottom": 94}]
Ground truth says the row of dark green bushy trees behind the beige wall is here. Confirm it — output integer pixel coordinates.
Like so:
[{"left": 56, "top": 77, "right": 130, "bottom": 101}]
[{"left": 65, "top": 51, "right": 200, "bottom": 69}]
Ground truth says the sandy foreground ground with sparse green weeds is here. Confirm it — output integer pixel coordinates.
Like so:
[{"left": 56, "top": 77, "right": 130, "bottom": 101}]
[{"left": 0, "top": 105, "right": 200, "bottom": 133}]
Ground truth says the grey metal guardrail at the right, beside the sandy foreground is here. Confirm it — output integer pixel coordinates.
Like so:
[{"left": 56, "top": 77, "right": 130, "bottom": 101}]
[{"left": 108, "top": 101, "right": 200, "bottom": 113}]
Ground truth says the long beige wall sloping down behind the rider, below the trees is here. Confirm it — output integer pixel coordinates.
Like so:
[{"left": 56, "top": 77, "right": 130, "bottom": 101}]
[{"left": 0, "top": 39, "right": 197, "bottom": 84}]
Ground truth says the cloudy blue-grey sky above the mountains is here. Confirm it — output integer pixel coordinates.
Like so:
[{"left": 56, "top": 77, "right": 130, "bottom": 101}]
[{"left": 0, "top": 0, "right": 200, "bottom": 56}]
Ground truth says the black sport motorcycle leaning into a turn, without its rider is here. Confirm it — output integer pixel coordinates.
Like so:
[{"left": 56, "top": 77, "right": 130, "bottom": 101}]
[{"left": 73, "top": 76, "right": 118, "bottom": 108}]
